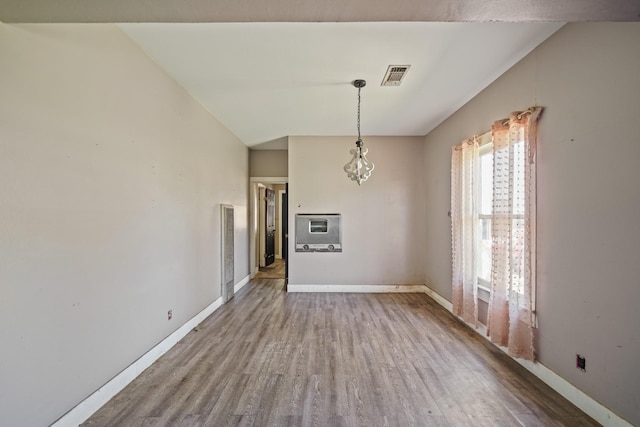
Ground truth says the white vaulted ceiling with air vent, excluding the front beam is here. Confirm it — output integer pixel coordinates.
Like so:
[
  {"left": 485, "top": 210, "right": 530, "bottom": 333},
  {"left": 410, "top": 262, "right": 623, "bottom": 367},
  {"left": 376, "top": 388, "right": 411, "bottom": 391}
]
[{"left": 117, "top": 22, "right": 560, "bottom": 146}]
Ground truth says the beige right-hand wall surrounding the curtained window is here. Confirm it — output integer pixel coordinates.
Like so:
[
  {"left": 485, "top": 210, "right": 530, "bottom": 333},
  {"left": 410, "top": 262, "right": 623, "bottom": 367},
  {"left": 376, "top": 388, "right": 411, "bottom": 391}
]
[{"left": 423, "top": 23, "right": 640, "bottom": 425}]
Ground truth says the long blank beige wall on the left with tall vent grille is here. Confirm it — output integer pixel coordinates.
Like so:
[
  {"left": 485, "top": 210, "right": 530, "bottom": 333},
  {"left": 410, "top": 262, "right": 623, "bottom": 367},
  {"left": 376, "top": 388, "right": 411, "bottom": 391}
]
[{"left": 0, "top": 24, "right": 249, "bottom": 426}]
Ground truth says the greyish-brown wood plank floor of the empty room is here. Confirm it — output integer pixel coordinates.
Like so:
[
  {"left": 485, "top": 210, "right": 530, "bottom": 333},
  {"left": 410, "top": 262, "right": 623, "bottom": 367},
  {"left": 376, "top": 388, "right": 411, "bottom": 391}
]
[{"left": 83, "top": 279, "right": 599, "bottom": 426}]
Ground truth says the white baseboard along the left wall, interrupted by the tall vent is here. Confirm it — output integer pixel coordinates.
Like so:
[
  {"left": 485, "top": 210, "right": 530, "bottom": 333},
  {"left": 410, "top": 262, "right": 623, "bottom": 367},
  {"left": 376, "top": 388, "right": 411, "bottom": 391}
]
[{"left": 51, "top": 276, "right": 249, "bottom": 427}]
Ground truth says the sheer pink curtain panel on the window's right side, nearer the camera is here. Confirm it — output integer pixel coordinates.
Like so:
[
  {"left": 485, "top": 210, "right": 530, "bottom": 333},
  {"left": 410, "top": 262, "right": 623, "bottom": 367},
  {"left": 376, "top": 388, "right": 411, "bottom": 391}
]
[{"left": 487, "top": 107, "right": 542, "bottom": 360}]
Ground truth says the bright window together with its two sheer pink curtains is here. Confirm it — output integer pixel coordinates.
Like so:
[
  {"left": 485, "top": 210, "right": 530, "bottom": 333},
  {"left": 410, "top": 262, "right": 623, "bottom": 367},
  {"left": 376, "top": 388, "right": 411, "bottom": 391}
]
[{"left": 451, "top": 107, "right": 542, "bottom": 360}]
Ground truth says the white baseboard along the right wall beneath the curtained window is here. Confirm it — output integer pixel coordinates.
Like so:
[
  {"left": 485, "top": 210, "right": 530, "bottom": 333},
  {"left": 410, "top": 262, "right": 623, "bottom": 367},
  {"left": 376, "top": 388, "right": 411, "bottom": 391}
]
[{"left": 425, "top": 286, "right": 633, "bottom": 427}]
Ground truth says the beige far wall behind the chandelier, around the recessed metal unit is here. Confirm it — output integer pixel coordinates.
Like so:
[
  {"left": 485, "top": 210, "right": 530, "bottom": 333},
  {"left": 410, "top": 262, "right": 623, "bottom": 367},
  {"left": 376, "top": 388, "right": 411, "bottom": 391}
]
[{"left": 289, "top": 137, "right": 425, "bottom": 285}]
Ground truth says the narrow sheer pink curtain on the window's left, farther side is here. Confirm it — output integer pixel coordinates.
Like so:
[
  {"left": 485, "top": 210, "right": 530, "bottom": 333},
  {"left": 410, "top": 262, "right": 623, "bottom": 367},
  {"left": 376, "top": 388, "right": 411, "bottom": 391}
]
[{"left": 451, "top": 139, "right": 480, "bottom": 326}]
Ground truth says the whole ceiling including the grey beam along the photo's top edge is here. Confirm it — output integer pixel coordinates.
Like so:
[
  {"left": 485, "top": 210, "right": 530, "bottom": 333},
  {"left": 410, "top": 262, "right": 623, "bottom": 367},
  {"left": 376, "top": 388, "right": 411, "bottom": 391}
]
[{"left": 0, "top": 0, "right": 640, "bottom": 149}]
